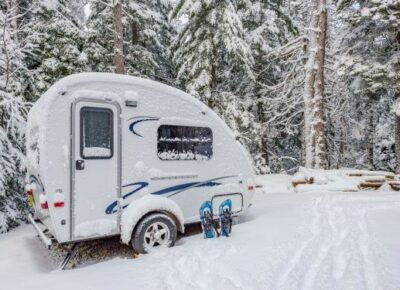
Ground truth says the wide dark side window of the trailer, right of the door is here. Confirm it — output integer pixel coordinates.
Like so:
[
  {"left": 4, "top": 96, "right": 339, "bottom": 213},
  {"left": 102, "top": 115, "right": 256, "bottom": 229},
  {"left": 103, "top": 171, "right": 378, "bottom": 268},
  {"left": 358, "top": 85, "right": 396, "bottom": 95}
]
[{"left": 157, "top": 125, "right": 213, "bottom": 160}]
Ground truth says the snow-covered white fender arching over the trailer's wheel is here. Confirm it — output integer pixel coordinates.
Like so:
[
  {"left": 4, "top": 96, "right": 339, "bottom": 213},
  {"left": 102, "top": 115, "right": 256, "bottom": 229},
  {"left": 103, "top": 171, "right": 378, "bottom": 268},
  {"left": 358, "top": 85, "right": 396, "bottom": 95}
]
[{"left": 121, "top": 194, "right": 185, "bottom": 244}]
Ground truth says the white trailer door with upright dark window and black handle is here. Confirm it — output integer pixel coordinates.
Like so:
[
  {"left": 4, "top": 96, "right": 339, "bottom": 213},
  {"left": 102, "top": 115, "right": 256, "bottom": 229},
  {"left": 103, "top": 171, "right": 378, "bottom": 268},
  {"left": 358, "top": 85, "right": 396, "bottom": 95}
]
[{"left": 71, "top": 100, "right": 121, "bottom": 240}]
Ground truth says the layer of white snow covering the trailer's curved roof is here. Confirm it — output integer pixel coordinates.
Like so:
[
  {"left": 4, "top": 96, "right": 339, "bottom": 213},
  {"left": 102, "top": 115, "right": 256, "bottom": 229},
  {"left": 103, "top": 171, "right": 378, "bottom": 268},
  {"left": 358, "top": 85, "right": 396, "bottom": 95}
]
[{"left": 28, "top": 73, "right": 247, "bottom": 170}]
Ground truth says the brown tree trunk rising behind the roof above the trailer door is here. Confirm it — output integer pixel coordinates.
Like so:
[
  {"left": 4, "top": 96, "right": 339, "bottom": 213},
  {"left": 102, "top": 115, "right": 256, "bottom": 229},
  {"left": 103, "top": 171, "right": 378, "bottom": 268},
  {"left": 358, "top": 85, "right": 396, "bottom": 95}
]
[{"left": 113, "top": 0, "right": 125, "bottom": 74}]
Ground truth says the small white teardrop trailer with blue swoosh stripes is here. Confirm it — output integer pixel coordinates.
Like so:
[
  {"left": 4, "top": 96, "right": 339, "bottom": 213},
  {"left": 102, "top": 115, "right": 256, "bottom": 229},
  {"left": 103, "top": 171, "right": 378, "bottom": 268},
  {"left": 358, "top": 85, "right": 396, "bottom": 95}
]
[{"left": 26, "top": 73, "right": 255, "bottom": 266}]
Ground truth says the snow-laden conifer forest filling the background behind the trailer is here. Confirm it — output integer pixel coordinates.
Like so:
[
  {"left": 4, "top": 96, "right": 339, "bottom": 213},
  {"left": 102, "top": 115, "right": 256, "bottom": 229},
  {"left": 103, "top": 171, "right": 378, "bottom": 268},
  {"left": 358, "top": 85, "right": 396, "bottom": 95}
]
[{"left": 0, "top": 0, "right": 400, "bottom": 233}]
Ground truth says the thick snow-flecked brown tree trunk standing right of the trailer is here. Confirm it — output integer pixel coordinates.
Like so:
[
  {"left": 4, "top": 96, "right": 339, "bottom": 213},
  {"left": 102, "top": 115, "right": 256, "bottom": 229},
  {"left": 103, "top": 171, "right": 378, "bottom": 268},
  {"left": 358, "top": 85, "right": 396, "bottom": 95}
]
[{"left": 304, "top": 0, "right": 328, "bottom": 168}]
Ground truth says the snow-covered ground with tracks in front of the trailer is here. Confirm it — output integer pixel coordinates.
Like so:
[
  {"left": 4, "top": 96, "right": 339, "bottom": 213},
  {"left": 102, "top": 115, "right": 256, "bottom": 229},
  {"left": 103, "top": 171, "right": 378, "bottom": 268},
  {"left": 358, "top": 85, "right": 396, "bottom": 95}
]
[{"left": 0, "top": 177, "right": 400, "bottom": 290}]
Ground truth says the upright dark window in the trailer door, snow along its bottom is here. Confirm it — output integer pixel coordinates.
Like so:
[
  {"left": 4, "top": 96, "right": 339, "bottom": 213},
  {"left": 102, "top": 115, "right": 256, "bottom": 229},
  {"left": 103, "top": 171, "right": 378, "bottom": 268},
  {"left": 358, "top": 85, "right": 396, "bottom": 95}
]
[{"left": 80, "top": 107, "right": 113, "bottom": 159}]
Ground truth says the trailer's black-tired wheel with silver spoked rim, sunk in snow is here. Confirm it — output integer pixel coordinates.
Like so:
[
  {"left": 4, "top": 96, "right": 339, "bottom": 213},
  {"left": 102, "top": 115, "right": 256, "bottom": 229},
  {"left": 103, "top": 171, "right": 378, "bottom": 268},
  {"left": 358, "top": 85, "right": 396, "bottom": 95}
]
[{"left": 131, "top": 213, "right": 177, "bottom": 254}]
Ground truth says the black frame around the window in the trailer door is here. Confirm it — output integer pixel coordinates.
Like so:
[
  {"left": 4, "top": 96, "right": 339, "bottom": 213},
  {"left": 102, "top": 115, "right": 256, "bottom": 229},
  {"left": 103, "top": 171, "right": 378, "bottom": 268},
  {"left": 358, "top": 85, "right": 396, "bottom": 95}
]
[{"left": 79, "top": 106, "right": 114, "bottom": 160}]
